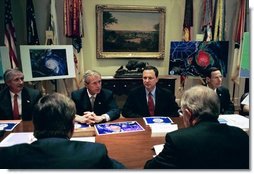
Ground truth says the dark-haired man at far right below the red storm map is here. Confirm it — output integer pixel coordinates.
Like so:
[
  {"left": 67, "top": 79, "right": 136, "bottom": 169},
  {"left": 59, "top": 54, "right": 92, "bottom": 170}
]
[{"left": 206, "top": 67, "right": 235, "bottom": 114}]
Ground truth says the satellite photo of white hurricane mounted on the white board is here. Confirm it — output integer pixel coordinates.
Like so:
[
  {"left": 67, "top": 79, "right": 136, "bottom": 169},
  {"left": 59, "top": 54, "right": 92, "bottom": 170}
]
[{"left": 30, "top": 49, "right": 68, "bottom": 78}]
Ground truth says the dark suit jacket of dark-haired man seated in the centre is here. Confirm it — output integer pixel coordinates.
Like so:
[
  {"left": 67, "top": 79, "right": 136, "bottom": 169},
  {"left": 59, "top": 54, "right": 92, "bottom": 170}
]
[{"left": 122, "top": 86, "right": 179, "bottom": 117}]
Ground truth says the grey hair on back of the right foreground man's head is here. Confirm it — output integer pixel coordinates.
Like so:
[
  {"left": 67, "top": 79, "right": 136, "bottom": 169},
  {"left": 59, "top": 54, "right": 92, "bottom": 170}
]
[{"left": 181, "top": 85, "right": 220, "bottom": 120}]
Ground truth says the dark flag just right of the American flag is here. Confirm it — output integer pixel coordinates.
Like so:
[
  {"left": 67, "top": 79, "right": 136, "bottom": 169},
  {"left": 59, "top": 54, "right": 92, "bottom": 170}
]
[{"left": 26, "top": 0, "right": 40, "bottom": 45}]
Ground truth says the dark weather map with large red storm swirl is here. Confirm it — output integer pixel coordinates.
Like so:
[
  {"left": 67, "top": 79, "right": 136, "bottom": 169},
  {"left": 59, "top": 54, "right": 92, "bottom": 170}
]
[{"left": 168, "top": 41, "right": 229, "bottom": 78}]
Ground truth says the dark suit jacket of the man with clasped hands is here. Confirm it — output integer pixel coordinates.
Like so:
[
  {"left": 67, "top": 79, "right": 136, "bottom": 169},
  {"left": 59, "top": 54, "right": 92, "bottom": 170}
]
[{"left": 71, "top": 88, "right": 120, "bottom": 120}]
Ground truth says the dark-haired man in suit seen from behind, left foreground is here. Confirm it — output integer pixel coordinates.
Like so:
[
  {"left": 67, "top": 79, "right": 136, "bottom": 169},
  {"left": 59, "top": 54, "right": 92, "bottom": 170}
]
[{"left": 0, "top": 93, "right": 124, "bottom": 169}]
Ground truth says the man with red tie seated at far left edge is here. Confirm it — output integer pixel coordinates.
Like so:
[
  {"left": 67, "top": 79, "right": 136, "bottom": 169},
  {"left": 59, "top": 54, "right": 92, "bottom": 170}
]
[{"left": 0, "top": 69, "right": 42, "bottom": 120}]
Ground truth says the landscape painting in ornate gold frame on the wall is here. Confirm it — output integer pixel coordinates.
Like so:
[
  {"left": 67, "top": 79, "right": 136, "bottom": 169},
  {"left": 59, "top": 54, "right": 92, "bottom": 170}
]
[{"left": 96, "top": 5, "right": 166, "bottom": 59}]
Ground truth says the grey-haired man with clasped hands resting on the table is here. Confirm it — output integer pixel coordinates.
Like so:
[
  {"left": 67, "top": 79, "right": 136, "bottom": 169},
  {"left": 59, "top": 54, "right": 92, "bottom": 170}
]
[{"left": 71, "top": 70, "right": 120, "bottom": 124}]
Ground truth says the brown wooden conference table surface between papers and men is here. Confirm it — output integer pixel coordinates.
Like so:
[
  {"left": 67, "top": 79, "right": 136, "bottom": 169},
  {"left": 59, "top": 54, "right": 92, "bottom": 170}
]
[{"left": 0, "top": 117, "right": 183, "bottom": 169}]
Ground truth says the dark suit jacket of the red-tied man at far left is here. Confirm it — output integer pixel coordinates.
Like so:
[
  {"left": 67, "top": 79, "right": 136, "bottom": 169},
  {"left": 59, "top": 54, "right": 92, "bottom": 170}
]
[{"left": 0, "top": 87, "right": 42, "bottom": 120}]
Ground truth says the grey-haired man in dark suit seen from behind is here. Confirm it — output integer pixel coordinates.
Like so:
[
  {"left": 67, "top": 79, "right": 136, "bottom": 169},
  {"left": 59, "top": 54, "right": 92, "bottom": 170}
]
[{"left": 144, "top": 86, "right": 249, "bottom": 169}]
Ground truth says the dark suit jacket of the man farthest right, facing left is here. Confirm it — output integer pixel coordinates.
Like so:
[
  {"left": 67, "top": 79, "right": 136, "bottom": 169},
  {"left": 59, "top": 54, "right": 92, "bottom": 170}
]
[{"left": 216, "top": 86, "right": 235, "bottom": 114}]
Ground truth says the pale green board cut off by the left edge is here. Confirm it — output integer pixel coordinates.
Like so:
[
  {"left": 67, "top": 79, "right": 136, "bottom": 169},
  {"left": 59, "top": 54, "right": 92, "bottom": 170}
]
[{"left": 0, "top": 46, "right": 11, "bottom": 84}]
